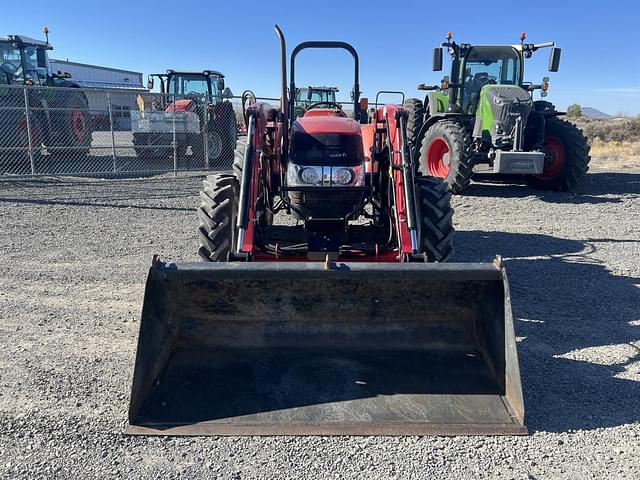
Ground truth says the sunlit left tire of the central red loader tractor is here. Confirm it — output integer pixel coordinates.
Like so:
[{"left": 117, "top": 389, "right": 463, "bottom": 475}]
[{"left": 198, "top": 174, "right": 240, "bottom": 262}]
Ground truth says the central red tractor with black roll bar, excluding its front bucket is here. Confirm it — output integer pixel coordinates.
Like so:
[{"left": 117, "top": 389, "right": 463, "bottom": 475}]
[{"left": 198, "top": 37, "right": 453, "bottom": 262}]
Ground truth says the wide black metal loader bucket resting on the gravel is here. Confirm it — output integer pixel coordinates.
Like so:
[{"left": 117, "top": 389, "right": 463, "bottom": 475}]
[{"left": 126, "top": 262, "right": 526, "bottom": 435}]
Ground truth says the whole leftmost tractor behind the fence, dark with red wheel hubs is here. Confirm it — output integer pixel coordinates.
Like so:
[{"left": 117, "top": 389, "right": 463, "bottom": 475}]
[{"left": 0, "top": 27, "right": 92, "bottom": 174}]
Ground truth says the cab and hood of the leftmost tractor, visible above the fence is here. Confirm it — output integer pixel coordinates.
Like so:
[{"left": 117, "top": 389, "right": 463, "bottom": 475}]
[{"left": 0, "top": 31, "right": 77, "bottom": 87}]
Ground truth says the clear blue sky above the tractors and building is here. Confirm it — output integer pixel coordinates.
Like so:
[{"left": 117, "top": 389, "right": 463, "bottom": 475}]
[{"left": 0, "top": 0, "right": 640, "bottom": 115}]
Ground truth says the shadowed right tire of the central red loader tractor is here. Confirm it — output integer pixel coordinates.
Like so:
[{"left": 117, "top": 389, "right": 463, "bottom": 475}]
[{"left": 415, "top": 177, "right": 455, "bottom": 262}]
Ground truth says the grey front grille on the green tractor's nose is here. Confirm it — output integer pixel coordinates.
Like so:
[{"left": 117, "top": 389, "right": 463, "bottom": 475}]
[{"left": 487, "top": 86, "right": 532, "bottom": 146}]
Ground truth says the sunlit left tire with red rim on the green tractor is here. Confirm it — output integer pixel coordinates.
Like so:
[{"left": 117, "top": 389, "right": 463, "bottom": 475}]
[{"left": 419, "top": 120, "right": 473, "bottom": 193}]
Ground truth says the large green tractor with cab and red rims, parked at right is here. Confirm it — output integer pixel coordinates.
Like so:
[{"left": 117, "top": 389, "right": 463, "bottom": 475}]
[{"left": 405, "top": 33, "right": 590, "bottom": 193}]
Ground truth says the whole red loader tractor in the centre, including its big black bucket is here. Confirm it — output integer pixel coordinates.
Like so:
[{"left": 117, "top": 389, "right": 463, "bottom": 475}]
[{"left": 127, "top": 27, "right": 526, "bottom": 435}]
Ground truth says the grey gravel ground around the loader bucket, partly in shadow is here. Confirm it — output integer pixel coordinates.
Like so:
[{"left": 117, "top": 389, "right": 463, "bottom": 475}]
[{"left": 0, "top": 172, "right": 640, "bottom": 479}]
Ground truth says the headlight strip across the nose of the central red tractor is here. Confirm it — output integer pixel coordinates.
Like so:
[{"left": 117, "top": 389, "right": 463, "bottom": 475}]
[{"left": 287, "top": 163, "right": 364, "bottom": 187}]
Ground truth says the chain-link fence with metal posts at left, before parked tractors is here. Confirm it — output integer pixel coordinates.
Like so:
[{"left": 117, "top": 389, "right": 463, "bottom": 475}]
[{"left": 0, "top": 86, "right": 279, "bottom": 175}]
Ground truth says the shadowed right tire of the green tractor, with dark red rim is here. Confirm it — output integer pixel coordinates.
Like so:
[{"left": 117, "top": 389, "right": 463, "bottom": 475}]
[{"left": 527, "top": 118, "right": 591, "bottom": 192}]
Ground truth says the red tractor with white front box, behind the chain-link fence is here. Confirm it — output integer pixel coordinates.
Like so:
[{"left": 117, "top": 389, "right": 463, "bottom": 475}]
[{"left": 132, "top": 70, "right": 238, "bottom": 169}]
